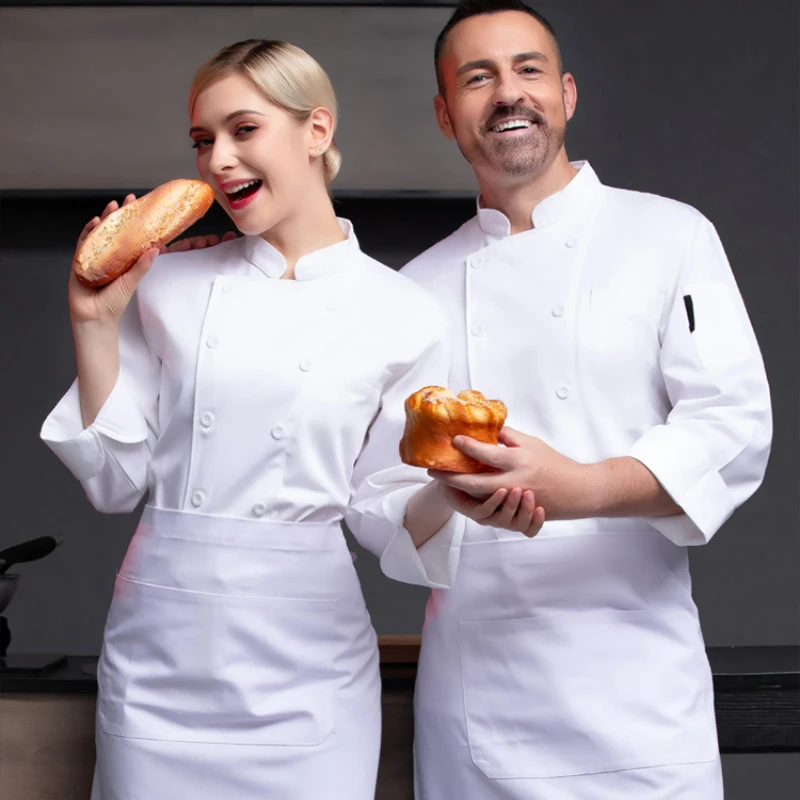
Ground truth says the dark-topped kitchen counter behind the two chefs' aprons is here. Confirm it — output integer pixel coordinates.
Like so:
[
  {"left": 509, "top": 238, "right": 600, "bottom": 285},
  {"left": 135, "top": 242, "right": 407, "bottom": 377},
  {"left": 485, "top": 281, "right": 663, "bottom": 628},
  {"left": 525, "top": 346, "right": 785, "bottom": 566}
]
[{"left": 0, "top": 636, "right": 800, "bottom": 800}]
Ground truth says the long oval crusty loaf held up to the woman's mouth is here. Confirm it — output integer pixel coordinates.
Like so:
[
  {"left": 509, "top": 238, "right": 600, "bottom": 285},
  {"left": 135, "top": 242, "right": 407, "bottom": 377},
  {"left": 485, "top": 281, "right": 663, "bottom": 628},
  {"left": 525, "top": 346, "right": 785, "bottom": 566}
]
[{"left": 72, "top": 180, "right": 214, "bottom": 288}]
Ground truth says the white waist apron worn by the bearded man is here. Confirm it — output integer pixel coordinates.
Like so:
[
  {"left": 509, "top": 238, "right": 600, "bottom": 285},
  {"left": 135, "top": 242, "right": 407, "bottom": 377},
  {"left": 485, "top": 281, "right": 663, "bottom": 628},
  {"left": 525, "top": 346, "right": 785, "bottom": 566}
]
[{"left": 415, "top": 520, "right": 722, "bottom": 800}]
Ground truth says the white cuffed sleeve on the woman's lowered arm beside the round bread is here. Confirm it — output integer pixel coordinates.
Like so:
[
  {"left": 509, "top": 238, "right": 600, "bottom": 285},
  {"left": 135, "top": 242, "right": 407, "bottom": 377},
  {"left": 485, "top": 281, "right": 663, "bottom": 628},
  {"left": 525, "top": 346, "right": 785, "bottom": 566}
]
[{"left": 345, "top": 314, "right": 466, "bottom": 588}]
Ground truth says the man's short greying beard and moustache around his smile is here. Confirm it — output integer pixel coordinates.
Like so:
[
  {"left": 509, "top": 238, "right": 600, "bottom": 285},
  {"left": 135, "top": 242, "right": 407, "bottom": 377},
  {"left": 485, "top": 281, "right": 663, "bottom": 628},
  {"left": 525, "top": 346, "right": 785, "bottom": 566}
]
[{"left": 461, "top": 106, "right": 567, "bottom": 178}]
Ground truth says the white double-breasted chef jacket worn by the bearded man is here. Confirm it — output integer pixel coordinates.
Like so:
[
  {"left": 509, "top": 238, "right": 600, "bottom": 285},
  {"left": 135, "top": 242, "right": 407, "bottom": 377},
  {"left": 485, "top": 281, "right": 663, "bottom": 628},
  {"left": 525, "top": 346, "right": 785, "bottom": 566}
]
[{"left": 402, "top": 162, "right": 772, "bottom": 545}]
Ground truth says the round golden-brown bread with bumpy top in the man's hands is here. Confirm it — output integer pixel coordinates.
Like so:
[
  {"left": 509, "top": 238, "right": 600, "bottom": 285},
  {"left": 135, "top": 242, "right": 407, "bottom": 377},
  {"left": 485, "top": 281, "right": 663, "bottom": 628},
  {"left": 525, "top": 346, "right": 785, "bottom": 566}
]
[{"left": 400, "top": 386, "right": 508, "bottom": 472}]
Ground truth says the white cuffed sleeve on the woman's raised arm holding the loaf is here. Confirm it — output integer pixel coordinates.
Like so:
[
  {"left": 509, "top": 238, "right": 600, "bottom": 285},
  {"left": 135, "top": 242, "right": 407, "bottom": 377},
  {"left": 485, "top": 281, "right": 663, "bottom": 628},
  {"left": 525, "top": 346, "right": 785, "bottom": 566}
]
[{"left": 41, "top": 295, "right": 161, "bottom": 514}]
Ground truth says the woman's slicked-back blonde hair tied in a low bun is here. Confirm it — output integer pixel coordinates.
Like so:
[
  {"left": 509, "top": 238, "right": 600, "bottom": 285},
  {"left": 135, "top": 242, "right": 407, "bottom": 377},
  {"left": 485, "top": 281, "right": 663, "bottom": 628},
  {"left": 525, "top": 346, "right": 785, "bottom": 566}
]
[{"left": 189, "top": 39, "right": 342, "bottom": 183}]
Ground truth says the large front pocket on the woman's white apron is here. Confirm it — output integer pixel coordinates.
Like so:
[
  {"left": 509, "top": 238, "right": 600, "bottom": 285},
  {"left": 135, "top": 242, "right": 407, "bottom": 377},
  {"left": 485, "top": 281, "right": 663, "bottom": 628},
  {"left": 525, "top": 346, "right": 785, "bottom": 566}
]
[{"left": 98, "top": 577, "right": 336, "bottom": 746}]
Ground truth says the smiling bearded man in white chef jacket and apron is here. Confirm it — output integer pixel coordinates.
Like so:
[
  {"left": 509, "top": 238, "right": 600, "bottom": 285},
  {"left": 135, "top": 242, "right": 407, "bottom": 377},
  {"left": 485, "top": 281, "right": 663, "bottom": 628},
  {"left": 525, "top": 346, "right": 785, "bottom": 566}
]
[{"left": 396, "top": 0, "right": 771, "bottom": 800}]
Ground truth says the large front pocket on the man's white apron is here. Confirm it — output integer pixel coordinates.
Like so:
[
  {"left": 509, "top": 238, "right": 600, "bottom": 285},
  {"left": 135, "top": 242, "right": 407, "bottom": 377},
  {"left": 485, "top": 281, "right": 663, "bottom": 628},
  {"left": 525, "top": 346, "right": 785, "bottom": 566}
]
[{"left": 460, "top": 610, "right": 717, "bottom": 779}]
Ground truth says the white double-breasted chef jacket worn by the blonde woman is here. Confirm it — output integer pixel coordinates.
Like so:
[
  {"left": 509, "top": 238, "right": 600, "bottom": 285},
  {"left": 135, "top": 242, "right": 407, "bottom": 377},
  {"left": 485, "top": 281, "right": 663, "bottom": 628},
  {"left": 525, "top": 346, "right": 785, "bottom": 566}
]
[{"left": 41, "top": 220, "right": 463, "bottom": 585}]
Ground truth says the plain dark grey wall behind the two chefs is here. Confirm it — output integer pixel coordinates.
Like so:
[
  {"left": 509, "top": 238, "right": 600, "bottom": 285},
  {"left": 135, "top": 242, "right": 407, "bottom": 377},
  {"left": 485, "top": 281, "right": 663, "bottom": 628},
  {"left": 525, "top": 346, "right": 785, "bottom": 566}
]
[{"left": 0, "top": 0, "right": 800, "bottom": 652}]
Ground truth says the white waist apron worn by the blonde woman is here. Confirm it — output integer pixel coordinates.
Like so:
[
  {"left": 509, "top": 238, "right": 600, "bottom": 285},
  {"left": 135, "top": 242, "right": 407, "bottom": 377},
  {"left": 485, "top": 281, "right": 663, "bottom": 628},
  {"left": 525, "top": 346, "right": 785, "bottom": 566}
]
[{"left": 92, "top": 506, "right": 381, "bottom": 800}]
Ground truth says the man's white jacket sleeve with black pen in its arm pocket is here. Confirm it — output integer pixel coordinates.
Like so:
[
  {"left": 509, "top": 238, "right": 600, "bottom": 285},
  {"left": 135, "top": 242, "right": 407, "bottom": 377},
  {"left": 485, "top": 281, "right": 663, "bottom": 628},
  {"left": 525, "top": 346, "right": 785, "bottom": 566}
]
[{"left": 630, "top": 216, "right": 772, "bottom": 545}]
